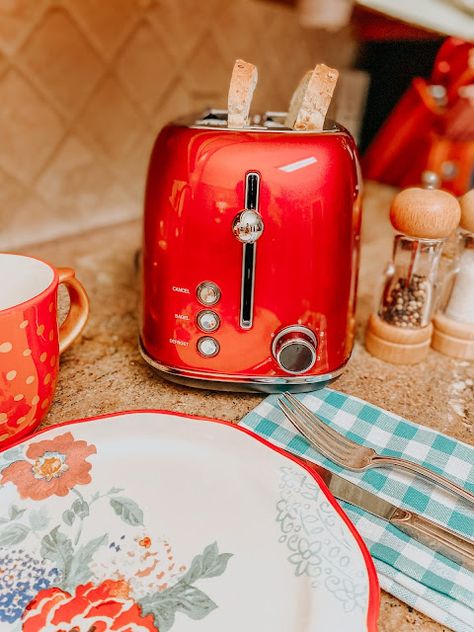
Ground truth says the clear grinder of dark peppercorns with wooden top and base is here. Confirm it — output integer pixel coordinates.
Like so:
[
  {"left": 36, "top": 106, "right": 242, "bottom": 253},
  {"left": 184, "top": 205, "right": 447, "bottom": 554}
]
[{"left": 365, "top": 172, "right": 461, "bottom": 364}]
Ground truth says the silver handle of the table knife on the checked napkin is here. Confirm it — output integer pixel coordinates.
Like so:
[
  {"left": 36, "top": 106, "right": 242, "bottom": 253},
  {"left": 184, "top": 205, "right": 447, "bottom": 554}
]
[{"left": 390, "top": 509, "right": 474, "bottom": 571}]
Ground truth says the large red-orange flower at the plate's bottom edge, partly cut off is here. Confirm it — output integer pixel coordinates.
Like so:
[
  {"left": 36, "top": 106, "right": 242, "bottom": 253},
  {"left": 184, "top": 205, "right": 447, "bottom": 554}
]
[{"left": 22, "top": 579, "right": 158, "bottom": 632}]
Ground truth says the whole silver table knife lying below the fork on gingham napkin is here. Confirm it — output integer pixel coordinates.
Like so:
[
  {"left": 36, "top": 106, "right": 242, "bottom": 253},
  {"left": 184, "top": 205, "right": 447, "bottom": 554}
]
[{"left": 293, "top": 455, "right": 474, "bottom": 571}]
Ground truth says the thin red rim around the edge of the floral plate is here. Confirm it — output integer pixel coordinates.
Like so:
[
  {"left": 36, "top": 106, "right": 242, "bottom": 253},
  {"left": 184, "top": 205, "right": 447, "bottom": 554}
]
[{"left": 0, "top": 408, "right": 380, "bottom": 632}]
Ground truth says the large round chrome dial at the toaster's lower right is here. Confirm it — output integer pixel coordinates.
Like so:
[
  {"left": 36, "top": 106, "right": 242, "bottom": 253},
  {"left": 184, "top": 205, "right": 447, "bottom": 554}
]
[{"left": 272, "top": 325, "right": 318, "bottom": 375}]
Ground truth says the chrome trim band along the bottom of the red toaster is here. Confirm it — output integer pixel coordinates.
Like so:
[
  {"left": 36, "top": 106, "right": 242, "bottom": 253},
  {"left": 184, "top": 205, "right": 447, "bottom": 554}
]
[{"left": 138, "top": 338, "right": 347, "bottom": 393}]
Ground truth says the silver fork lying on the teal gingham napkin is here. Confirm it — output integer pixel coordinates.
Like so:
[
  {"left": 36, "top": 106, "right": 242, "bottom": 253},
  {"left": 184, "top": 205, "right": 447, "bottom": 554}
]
[{"left": 278, "top": 393, "right": 474, "bottom": 504}]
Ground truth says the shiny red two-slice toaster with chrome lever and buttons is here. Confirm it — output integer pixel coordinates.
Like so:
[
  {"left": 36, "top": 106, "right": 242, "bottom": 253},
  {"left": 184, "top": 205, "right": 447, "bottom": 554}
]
[{"left": 140, "top": 110, "right": 361, "bottom": 392}]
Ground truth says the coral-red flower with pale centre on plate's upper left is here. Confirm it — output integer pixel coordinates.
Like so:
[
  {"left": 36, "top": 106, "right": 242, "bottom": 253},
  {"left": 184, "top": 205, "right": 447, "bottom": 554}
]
[{"left": 0, "top": 432, "right": 97, "bottom": 500}]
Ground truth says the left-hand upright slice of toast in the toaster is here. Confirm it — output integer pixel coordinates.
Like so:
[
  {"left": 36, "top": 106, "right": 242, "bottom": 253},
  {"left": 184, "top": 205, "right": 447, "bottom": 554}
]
[{"left": 227, "top": 59, "right": 258, "bottom": 128}]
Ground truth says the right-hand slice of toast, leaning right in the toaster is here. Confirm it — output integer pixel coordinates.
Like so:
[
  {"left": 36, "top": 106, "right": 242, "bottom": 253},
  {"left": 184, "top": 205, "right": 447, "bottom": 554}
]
[{"left": 286, "top": 64, "right": 339, "bottom": 132}]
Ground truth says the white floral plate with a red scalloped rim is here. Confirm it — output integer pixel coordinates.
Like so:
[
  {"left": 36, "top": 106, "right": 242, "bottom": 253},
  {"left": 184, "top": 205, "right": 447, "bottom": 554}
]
[{"left": 0, "top": 411, "right": 379, "bottom": 632}]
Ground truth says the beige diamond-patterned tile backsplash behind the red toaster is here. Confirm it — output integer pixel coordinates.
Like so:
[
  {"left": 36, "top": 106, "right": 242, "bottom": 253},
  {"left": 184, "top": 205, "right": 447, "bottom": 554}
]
[{"left": 0, "top": 0, "right": 355, "bottom": 249}]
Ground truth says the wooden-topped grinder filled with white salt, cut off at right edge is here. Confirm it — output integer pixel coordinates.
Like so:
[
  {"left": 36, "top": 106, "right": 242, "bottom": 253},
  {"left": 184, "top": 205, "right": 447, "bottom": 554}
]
[{"left": 431, "top": 189, "right": 474, "bottom": 360}]
